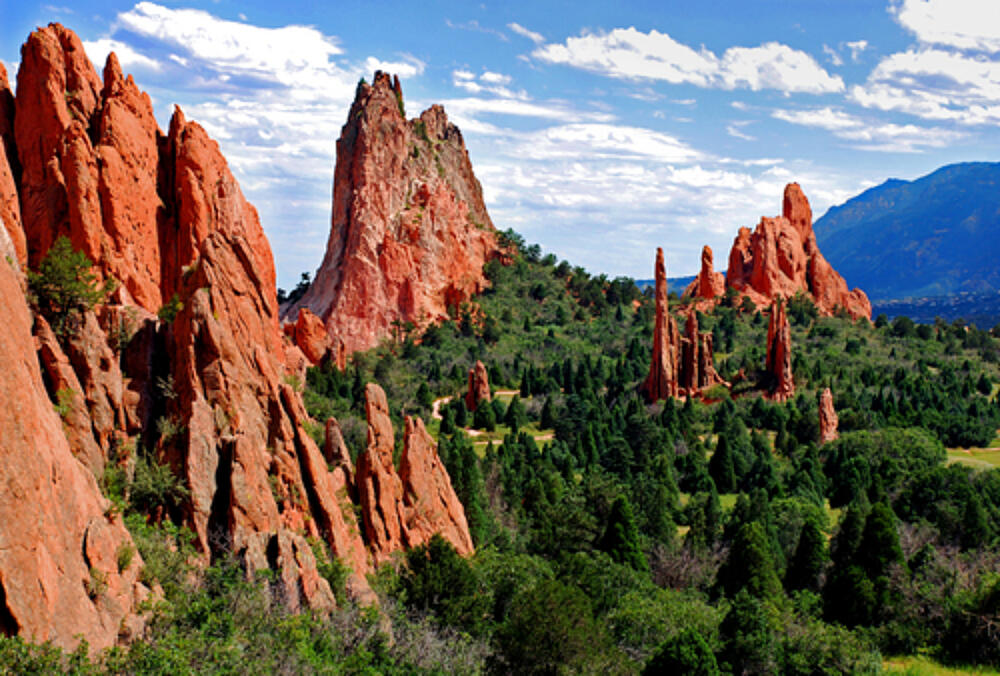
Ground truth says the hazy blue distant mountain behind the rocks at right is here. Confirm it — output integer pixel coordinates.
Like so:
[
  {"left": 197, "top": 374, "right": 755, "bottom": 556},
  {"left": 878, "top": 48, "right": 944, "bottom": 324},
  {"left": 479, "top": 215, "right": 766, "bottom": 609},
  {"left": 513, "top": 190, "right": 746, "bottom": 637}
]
[{"left": 813, "top": 162, "right": 1000, "bottom": 305}]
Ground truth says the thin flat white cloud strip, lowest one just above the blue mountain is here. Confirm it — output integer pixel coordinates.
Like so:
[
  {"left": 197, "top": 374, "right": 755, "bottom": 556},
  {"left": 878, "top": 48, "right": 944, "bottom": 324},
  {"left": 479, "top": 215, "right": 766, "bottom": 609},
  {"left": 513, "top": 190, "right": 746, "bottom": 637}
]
[{"left": 772, "top": 107, "right": 964, "bottom": 153}]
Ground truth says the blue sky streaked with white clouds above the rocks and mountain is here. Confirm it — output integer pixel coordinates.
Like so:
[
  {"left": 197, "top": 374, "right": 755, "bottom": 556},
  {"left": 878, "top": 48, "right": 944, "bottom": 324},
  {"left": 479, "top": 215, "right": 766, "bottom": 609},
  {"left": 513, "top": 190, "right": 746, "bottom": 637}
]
[{"left": 0, "top": 0, "right": 1000, "bottom": 288}]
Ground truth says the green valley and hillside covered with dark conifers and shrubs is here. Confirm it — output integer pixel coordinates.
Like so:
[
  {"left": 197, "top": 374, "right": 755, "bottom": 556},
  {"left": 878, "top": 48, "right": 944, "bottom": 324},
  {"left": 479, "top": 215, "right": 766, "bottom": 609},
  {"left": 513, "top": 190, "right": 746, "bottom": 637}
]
[{"left": 9, "top": 233, "right": 1000, "bottom": 674}]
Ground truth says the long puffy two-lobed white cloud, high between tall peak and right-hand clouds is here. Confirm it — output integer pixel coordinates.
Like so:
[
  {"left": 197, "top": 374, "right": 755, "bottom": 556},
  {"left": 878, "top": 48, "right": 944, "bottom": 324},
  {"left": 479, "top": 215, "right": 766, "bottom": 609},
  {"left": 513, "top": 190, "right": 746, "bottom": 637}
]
[{"left": 532, "top": 27, "right": 844, "bottom": 94}]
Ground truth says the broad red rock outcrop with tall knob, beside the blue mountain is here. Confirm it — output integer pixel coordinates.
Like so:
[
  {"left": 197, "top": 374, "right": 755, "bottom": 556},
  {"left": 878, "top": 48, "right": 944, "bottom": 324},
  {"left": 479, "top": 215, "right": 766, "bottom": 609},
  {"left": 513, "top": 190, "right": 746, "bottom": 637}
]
[{"left": 726, "top": 183, "right": 871, "bottom": 319}]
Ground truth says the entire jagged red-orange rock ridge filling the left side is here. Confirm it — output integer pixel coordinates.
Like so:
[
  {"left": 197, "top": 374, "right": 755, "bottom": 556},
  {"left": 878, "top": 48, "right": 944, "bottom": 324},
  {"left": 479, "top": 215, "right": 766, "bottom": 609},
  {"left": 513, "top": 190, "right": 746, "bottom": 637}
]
[{"left": 0, "top": 24, "right": 472, "bottom": 647}]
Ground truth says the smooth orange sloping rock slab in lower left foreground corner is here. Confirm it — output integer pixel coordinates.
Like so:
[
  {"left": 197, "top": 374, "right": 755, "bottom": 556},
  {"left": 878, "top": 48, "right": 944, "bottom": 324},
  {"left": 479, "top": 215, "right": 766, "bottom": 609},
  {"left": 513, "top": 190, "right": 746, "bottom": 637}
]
[{"left": 0, "top": 230, "right": 148, "bottom": 649}]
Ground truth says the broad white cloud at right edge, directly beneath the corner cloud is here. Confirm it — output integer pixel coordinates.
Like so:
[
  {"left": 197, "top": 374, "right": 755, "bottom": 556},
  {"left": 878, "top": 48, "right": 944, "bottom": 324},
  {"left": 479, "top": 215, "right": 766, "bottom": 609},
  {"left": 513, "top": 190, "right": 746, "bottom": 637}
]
[{"left": 850, "top": 49, "right": 1000, "bottom": 125}]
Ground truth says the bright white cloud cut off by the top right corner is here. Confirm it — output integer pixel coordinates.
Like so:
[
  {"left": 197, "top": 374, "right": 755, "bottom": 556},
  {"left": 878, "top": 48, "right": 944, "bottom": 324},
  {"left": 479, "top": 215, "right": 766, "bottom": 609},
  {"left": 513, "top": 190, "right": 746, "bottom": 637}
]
[{"left": 889, "top": 0, "right": 1000, "bottom": 52}]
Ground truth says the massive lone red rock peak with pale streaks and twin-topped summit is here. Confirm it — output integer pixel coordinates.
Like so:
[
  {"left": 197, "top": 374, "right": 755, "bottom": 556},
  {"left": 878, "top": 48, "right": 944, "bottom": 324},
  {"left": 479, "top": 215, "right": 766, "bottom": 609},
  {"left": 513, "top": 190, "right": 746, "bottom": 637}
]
[{"left": 284, "top": 72, "right": 498, "bottom": 352}]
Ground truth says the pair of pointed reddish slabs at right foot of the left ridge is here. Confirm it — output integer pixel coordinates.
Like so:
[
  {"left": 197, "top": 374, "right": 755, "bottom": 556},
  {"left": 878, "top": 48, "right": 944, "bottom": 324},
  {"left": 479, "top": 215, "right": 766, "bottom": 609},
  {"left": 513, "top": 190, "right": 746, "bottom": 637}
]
[{"left": 356, "top": 384, "right": 473, "bottom": 565}]
